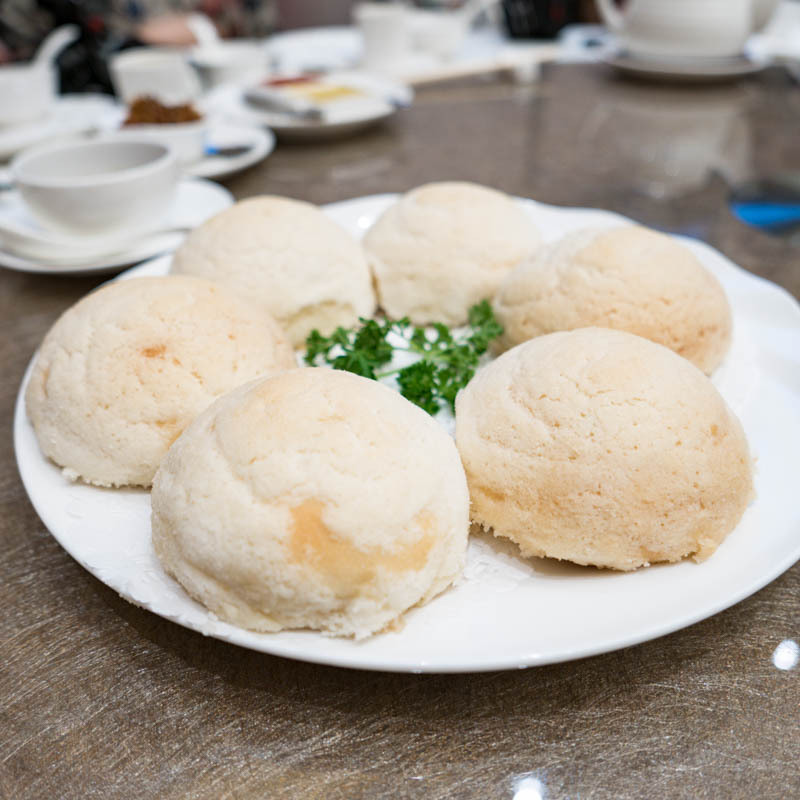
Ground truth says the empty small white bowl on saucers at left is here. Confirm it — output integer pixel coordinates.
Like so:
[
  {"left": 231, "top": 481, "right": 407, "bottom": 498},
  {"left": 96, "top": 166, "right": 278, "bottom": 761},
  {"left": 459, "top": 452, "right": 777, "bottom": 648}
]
[{"left": 11, "top": 137, "right": 180, "bottom": 234}]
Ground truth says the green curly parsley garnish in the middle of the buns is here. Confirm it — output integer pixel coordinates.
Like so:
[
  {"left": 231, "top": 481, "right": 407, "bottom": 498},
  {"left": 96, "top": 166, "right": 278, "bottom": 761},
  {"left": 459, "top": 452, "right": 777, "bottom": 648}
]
[{"left": 305, "top": 300, "right": 503, "bottom": 414}]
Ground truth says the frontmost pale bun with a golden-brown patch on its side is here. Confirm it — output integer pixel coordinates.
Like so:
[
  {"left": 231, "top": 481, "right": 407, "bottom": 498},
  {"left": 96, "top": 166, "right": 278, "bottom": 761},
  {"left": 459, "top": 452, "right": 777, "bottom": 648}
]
[{"left": 152, "top": 368, "right": 469, "bottom": 638}]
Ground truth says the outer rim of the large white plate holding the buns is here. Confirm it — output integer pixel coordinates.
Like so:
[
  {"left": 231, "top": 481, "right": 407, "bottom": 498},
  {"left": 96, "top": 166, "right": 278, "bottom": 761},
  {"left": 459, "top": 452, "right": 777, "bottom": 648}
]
[{"left": 13, "top": 193, "right": 800, "bottom": 674}]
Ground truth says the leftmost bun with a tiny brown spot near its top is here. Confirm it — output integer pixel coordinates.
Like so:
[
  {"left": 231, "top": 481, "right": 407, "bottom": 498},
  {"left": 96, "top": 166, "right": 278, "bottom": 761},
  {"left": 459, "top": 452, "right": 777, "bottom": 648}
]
[{"left": 25, "top": 276, "right": 296, "bottom": 486}]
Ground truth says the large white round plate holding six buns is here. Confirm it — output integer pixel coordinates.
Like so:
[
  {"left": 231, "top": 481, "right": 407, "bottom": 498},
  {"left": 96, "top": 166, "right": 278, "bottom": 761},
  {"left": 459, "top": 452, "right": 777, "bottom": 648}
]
[{"left": 14, "top": 195, "right": 800, "bottom": 672}]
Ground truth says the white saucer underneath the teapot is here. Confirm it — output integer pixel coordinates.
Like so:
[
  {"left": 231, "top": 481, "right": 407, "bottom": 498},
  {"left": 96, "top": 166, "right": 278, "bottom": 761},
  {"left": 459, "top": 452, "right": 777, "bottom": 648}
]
[{"left": 602, "top": 51, "right": 766, "bottom": 83}]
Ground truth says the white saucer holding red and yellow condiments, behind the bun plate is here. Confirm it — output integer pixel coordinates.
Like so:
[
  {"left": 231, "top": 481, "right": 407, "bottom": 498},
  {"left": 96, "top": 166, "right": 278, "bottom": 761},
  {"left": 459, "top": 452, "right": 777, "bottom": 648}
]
[{"left": 203, "top": 70, "right": 414, "bottom": 141}]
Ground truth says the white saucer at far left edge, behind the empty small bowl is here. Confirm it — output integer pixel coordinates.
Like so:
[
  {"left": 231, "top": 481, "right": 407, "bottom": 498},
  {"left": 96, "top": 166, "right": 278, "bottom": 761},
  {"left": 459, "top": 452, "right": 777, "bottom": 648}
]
[{"left": 0, "top": 94, "right": 125, "bottom": 161}]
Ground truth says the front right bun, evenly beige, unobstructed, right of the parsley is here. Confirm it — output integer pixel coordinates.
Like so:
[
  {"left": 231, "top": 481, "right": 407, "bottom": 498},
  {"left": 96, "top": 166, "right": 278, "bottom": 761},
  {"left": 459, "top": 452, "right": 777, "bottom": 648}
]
[{"left": 456, "top": 328, "right": 753, "bottom": 570}]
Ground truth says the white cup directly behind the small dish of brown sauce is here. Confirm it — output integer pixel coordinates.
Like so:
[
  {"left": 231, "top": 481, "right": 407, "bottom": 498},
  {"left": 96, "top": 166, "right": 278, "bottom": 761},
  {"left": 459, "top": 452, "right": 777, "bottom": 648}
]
[{"left": 110, "top": 47, "right": 201, "bottom": 105}]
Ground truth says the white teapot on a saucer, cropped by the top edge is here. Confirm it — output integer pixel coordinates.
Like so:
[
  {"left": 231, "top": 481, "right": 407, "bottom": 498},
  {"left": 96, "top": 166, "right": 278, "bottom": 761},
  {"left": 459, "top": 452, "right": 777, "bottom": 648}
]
[{"left": 597, "top": 0, "right": 777, "bottom": 58}]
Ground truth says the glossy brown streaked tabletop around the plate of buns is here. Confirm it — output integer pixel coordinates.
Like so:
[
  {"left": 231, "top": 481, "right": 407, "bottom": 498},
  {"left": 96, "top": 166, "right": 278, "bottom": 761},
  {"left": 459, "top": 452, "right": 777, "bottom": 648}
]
[{"left": 0, "top": 65, "right": 800, "bottom": 800}]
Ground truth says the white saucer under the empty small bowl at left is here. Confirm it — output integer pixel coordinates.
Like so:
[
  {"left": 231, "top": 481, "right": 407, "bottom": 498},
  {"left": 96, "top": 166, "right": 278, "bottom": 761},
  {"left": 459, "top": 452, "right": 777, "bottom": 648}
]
[{"left": 0, "top": 178, "right": 234, "bottom": 275}]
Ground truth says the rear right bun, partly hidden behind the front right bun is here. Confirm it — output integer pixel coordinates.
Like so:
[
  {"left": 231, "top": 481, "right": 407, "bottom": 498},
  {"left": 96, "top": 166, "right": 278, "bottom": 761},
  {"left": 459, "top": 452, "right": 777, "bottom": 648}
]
[{"left": 494, "top": 225, "right": 731, "bottom": 374}]
